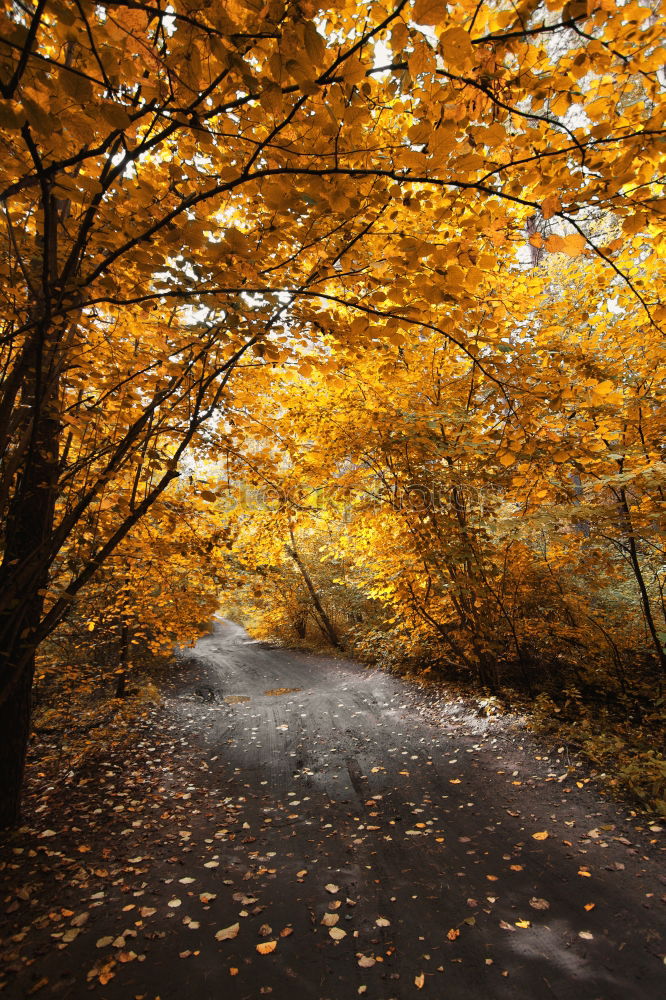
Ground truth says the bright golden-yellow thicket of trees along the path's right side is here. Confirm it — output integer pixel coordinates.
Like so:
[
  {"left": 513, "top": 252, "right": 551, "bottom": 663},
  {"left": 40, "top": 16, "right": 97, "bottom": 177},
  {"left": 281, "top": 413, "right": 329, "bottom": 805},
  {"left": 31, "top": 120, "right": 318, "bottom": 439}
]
[{"left": 219, "top": 254, "right": 664, "bottom": 695}]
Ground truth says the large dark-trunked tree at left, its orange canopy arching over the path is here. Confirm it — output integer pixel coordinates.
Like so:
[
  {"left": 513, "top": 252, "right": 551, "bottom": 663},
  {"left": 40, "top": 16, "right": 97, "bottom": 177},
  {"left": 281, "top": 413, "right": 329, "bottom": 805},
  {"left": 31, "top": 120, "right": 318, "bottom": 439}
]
[{"left": 0, "top": 0, "right": 664, "bottom": 823}]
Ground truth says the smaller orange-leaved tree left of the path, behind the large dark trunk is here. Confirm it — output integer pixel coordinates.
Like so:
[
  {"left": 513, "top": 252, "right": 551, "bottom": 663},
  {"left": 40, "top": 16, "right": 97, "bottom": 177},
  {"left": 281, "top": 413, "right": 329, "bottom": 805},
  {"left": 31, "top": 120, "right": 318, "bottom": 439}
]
[{"left": 46, "top": 477, "right": 226, "bottom": 697}]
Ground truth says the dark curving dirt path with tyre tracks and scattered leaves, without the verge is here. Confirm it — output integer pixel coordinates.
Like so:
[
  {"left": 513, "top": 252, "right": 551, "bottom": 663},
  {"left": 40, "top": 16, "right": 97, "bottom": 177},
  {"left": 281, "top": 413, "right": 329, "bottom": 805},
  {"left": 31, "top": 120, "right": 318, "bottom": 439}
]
[{"left": 158, "top": 622, "right": 666, "bottom": 1000}]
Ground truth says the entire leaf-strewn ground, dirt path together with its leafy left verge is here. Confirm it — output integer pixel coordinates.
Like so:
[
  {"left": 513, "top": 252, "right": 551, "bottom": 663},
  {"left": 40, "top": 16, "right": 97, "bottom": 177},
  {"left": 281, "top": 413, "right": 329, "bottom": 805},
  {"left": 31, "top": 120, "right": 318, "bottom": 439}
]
[{"left": 0, "top": 622, "right": 666, "bottom": 1000}]
